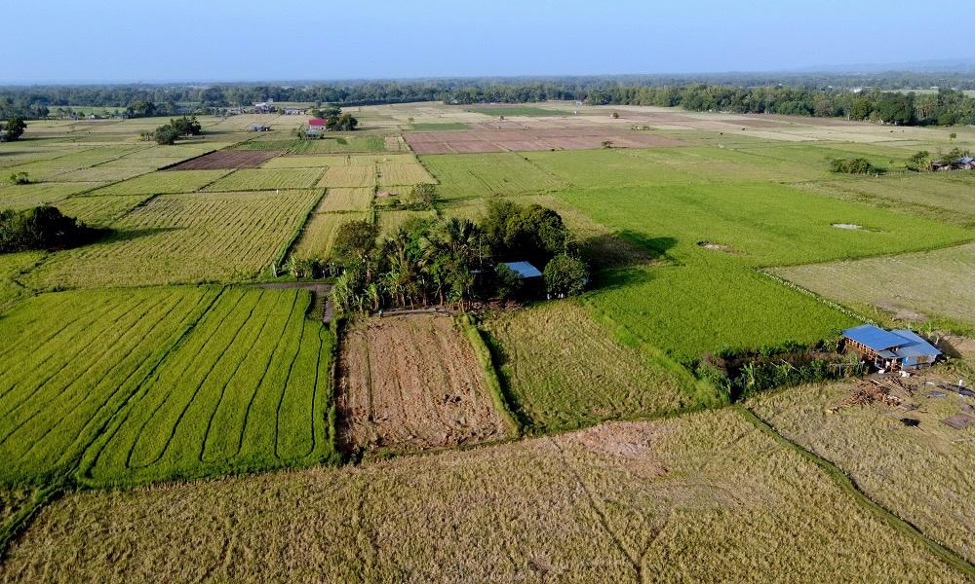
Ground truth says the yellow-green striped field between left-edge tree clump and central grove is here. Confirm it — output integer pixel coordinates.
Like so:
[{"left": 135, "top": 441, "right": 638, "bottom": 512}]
[{"left": 29, "top": 191, "right": 321, "bottom": 289}]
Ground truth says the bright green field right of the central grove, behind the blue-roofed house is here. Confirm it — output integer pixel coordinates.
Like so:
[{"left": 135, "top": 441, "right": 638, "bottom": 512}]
[{"left": 559, "top": 183, "right": 969, "bottom": 362}]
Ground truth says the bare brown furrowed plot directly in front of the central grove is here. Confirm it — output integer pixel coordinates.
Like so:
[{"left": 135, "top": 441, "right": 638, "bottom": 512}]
[{"left": 338, "top": 314, "right": 507, "bottom": 451}]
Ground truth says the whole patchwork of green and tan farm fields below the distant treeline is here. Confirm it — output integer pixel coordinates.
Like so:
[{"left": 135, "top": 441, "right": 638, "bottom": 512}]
[{"left": 0, "top": 102, "right": 974, "bottom": 581}]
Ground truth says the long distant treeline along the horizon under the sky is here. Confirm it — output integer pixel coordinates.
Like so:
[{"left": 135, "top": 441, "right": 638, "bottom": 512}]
[{"left": 0, "top": 72, "right": 974, "bottom": 125}]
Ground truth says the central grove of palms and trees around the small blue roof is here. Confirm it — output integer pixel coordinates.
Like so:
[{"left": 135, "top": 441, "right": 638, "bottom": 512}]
[{"left": 329, "top": 202, "right": 589, "bottom": 312}]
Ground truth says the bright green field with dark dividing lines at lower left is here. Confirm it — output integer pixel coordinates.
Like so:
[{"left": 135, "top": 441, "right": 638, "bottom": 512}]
[{"left": 0, "top": 288, "right": 333, "bottom": 485}]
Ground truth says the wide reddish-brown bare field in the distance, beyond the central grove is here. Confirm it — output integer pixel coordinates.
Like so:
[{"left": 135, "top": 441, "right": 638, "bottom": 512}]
[{"left": 403, "top": 122, "right": 682, "bottom": 154}]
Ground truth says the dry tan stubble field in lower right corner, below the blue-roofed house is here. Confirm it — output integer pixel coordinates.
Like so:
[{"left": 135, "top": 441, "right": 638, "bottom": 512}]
[{"left": 748, "top": 380, "right": 974, "bottom": 562}]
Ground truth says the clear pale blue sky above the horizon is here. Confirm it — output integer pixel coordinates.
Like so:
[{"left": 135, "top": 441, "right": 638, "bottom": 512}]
[{"left": 0, "top": 0, "right": 976, "bottom": 84}]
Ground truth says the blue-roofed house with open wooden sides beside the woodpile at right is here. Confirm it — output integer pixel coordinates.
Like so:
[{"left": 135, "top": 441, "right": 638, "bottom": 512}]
[{"left": 844, "top": 324, "right": 942, "bottom": 371}]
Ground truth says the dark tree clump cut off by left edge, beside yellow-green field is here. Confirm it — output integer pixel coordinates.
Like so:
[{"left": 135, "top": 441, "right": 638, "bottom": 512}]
[{"left": 0, "top": 205, "right": 107, "bottom": 253}]
